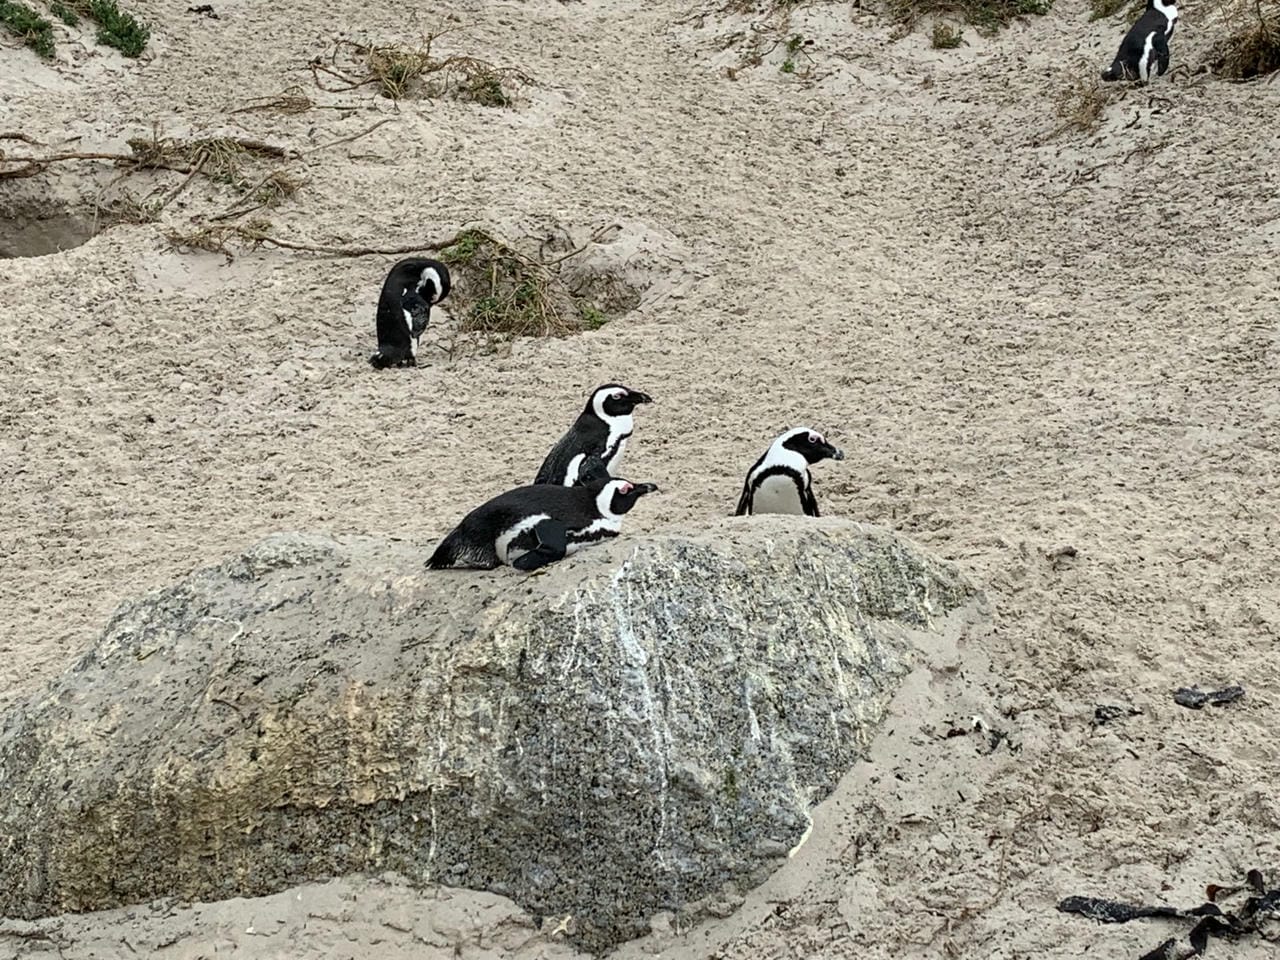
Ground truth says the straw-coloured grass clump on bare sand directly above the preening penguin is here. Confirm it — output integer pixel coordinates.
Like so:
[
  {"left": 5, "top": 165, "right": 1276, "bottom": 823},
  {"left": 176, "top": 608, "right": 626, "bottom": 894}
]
[{"left": 310, "top": 33, "right": 532, "bottom": 106}]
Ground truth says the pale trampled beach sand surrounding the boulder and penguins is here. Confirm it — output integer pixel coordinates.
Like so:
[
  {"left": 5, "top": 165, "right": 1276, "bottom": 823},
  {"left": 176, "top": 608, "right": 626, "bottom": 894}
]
[{"left": 0, "top": 0, "right": 1280, "bottom": 960}]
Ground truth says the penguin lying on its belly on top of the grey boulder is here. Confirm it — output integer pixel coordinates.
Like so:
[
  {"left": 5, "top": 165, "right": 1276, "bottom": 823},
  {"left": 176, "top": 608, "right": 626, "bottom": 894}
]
[{"left": 426, "top": 477, "right": 658, "bottom": 572}]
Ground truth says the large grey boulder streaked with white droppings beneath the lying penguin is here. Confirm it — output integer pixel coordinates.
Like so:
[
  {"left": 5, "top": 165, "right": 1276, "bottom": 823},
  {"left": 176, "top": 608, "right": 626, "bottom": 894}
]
[{"left": 0, "top": 517, "right": 974, "bottom": 948}]
